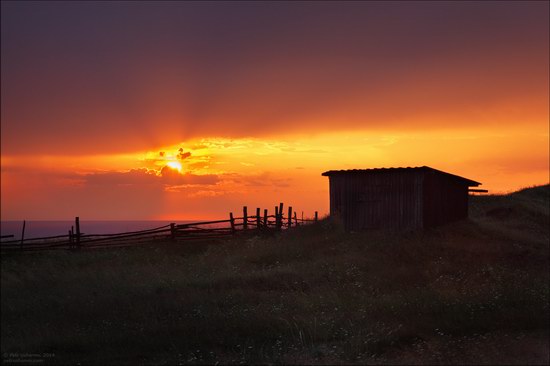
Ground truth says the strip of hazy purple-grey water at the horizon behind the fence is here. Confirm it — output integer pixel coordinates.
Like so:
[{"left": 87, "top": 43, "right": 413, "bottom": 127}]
[{"left": 0, "top": 220, "right": 191, "bottom": 240}]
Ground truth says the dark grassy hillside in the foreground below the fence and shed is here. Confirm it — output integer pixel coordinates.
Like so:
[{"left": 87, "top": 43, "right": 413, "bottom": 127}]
[{"left": 1, "top": 186, "right": 550, "bottom": 365}]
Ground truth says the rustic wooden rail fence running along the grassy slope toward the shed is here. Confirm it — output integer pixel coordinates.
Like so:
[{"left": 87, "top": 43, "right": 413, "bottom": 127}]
[{"left": 0, "top": 203, "right": 318, "bottom": 252}]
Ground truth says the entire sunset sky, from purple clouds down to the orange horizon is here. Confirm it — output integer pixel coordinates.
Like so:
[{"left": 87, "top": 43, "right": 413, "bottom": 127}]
[{"left": 1, "top": 1, "right": 550, "bottom": 220}]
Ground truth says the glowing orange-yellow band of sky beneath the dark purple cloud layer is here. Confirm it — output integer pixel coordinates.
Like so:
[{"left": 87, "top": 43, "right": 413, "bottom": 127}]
[{"left": 2, "top": 129, "right": 548, "bottom": 220}]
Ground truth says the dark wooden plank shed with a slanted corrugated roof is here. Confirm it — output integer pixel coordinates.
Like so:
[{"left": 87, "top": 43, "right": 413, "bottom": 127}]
[{"left": 322, "top": 166, "right": 481, "bottom": 230}]
